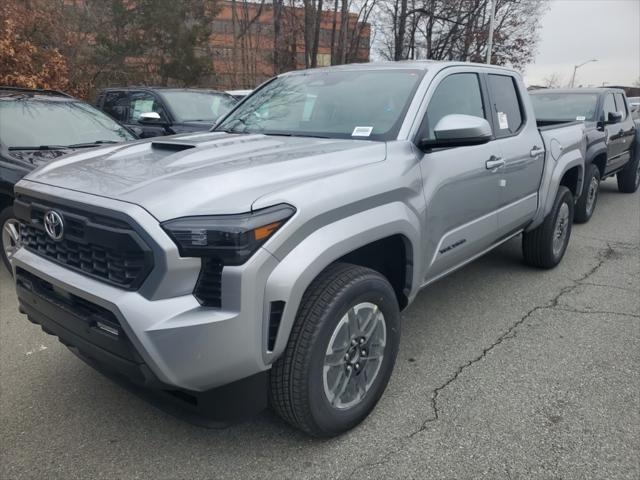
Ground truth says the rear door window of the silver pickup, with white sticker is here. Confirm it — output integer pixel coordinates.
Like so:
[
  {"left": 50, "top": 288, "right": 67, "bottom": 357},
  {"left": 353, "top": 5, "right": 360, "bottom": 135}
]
[{"left": 489, "top": 74, "right": 524, "bottom": 138}]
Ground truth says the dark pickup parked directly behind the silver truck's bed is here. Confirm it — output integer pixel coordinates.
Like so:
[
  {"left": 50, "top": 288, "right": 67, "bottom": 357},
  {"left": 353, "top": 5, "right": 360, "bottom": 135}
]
[{"left": 530, "top": 88, "right": 640, "bottom": 222}]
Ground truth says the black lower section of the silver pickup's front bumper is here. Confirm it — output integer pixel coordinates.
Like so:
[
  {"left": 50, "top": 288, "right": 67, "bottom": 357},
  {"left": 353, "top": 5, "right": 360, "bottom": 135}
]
[{"left": 15, "top": 262, "right": 268, "bottom": 420}]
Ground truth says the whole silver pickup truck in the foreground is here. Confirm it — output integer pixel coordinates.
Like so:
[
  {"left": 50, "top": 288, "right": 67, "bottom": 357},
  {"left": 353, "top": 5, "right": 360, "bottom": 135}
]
[{"left": 12, "top": 62, "right": 585, "bottom": 436}]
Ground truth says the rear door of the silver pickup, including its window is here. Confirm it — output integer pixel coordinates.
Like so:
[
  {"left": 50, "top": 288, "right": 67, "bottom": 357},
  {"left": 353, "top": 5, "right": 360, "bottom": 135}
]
[{"left": 486, "top": 73, "right": 544, "bottom": 235}]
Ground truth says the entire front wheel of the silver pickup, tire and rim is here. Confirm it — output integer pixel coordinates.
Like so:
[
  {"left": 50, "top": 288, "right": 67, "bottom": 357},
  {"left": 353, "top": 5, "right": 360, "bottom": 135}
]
[{"left": 270, "top": 263, "right": 400, "bottom": 437}]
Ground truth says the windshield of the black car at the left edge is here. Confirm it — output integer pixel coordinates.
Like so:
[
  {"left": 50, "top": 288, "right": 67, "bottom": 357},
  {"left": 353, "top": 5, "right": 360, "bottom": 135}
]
[{"left": 0, "top": 99, "right": 134, "bottom": 148}]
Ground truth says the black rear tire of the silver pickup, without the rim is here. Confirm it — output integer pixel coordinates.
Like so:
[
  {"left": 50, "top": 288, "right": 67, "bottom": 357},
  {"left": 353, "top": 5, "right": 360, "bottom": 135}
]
[{"left": 522, "top": 186, "right": 573, "bottom": 268}]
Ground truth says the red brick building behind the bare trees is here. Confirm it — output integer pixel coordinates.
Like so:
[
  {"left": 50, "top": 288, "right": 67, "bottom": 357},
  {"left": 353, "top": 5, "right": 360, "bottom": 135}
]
[{"left": 211, "top": 1, "right": 371, "bottom": 89}]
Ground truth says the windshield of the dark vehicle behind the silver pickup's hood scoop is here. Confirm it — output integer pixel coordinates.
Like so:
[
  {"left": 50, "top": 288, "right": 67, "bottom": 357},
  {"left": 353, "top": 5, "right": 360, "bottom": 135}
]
[{"left": 162, "top": 90, "right": 236, "bottom": 123}]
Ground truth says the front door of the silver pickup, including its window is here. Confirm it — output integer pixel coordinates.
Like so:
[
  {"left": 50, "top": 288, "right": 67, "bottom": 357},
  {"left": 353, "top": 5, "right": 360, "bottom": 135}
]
[{"left": 418, "top": 72, "right": 500, "bottom": 283}]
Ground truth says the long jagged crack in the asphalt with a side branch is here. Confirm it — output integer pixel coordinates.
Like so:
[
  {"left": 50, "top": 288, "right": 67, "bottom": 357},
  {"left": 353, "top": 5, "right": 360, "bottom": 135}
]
[{"left": 346, "top": 242, "right": 624, "bottom": 478}]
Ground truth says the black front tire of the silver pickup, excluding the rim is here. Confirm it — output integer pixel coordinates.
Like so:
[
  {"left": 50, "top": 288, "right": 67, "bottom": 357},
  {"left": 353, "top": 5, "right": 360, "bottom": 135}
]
[{"left": 270, "top": 263, "right": 400, "bottom": 437}]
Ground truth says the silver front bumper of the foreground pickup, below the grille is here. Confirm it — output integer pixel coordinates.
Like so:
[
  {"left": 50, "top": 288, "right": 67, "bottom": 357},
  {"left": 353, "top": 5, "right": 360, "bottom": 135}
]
[{"left": 12, "top": 244, "right": 273, "bottom": 391}]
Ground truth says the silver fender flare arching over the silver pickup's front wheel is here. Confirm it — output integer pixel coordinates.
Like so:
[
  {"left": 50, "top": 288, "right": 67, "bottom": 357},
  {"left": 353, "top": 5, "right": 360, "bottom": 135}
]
[{"left": 262, "top": 202, "right": 422, "bottom": 365}]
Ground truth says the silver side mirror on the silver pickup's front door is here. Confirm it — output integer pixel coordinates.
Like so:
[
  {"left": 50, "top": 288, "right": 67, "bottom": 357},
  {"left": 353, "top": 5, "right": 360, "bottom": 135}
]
[{"left": 418, "top": 114, "right": 492, "bottom": 149}]
